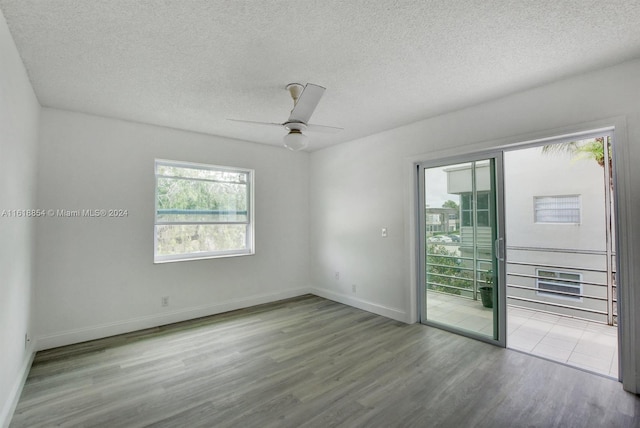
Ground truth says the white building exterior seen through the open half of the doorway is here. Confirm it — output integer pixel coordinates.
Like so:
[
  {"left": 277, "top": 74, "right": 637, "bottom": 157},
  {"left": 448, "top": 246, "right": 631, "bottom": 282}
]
[{"left": 505, "top": 142, "right": 615, "bottom": 322}]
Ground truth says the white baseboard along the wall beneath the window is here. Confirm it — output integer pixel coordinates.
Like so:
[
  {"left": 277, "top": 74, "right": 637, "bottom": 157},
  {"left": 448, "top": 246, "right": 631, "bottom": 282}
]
[{"left": 37, "top": 287, "right": 311, "bottom": 351}]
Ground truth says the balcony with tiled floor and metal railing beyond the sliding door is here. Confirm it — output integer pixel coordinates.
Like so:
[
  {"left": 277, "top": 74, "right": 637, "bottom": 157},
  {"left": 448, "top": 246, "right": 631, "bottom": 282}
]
[{"left": 426, "top": 241, "right": 618, "bottom": 378}]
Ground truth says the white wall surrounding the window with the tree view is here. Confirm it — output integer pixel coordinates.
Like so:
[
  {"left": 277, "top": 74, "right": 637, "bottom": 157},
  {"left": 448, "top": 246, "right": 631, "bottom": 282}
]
[{"left": 35, "top": 109, "right": 309, "bottom": 349}]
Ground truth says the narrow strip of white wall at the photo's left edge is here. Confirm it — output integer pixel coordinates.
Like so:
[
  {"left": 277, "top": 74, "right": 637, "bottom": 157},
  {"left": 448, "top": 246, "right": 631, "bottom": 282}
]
[{"left": 0, "top": 7, "right": 40, "bottom": 426}]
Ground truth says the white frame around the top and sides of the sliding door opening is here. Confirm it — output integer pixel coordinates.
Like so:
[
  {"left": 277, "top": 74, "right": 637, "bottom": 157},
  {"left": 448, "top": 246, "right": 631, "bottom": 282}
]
[{"left": 404, "top": 116, "right": 640, "bottom": 393}]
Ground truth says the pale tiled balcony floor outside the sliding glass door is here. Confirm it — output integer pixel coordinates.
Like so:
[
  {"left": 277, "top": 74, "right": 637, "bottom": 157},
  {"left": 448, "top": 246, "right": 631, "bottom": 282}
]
[{"left": 427, "top": 292, "right": 618, "bottom": 379}]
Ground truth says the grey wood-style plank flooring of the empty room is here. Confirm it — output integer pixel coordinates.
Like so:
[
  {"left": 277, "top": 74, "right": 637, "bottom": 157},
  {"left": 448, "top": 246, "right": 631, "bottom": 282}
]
[{"left": 10, "top": 296, "right": 640, "bottom": 428}]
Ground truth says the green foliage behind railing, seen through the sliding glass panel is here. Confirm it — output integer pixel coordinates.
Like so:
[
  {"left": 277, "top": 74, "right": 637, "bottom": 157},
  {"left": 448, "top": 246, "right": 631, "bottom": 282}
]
[{"left": 427, "top": 244, "right": 473, "bottom": 295}]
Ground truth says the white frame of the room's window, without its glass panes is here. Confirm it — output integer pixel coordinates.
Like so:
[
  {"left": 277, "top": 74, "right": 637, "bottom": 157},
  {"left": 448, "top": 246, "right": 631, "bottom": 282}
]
[{"left": 153, "top": 159, "right": 255, "bottom": 263}]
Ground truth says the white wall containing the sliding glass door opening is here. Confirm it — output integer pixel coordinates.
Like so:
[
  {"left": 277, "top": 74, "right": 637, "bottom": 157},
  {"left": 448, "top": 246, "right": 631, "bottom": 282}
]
[{"left": 310, "top": 61, "right": 640, "bottom": 390}]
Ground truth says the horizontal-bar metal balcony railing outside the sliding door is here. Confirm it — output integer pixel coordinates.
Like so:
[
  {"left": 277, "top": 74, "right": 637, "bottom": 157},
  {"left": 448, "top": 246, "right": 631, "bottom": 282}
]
[{"left": 426, "top": 247, "right": 617, "bottom": 325}]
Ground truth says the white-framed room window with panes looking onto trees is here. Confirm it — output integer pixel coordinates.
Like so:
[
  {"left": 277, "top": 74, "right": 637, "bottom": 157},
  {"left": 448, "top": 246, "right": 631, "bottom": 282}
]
[{"left": 154, "top": 160, "right": 254, "bottom": 263}]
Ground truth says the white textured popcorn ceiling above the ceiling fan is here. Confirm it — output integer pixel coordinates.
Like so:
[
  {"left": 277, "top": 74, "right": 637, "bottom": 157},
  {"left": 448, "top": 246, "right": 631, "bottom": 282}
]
[{"left": 0, "top": 0, "right": 640, "bottom": 150}]
